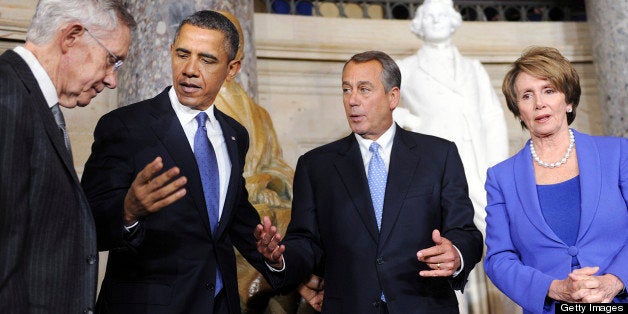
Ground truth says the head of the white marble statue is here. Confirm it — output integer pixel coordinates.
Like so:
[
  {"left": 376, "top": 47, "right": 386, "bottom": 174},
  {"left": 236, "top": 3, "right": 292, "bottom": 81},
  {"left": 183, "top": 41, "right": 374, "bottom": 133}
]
[{"left": 410, "top": 0, "right": 462, "bottom": 43}]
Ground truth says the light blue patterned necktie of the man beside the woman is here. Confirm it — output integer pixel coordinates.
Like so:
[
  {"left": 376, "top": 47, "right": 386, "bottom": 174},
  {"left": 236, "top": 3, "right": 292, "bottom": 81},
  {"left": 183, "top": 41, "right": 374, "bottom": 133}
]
[{"left": 368, "top": 142, "right": 388, "bottom": 229}]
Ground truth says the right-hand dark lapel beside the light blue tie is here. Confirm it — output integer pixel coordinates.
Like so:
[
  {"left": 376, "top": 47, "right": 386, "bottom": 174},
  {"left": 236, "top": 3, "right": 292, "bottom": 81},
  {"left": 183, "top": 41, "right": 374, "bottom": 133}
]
[{"left": 380, "top": 126, "right": 421, "bottom": 247}]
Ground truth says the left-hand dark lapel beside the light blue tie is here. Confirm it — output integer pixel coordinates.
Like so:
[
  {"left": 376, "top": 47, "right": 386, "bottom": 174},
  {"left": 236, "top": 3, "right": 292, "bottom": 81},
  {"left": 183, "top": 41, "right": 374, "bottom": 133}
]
[{"left": 334, "top": 133, "right": 378, "bottom": 243}]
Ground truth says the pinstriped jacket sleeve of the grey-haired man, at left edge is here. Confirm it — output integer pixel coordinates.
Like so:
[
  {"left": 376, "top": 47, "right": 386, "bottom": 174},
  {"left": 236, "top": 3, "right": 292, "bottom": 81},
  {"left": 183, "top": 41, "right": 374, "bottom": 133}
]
[{"left": 0, "top": 77, "right": 29, "bottom": 313}]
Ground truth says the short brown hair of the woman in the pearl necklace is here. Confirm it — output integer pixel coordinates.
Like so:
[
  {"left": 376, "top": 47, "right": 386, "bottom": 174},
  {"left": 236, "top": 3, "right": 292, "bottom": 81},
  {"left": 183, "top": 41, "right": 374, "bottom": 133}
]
[{"left": 502, "top": 47, "right": 581, "bottom": 128}]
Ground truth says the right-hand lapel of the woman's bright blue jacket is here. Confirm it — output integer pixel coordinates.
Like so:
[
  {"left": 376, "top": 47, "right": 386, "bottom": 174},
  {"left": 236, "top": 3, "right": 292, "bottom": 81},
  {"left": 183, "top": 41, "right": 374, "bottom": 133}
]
[{"left": 574, "top": 131, "right": 602, "bottom": 241}]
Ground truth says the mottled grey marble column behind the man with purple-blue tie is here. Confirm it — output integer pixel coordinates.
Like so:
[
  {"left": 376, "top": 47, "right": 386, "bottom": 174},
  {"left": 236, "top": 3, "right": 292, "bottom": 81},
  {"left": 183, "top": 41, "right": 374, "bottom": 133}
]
[{"left": 117, "top": 0, "right": 257, "bottom": 107}]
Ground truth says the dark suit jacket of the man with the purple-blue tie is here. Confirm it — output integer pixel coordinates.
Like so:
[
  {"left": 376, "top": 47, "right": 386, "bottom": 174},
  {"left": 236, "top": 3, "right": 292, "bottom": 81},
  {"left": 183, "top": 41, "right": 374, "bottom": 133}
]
[{"left": 82, "top": 89, "right": 276, "bottom": 313}]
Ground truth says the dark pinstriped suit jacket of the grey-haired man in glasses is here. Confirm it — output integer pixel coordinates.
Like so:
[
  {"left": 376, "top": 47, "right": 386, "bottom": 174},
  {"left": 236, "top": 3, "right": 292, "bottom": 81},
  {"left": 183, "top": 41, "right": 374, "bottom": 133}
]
[{"left": 0, "top": 51, "right": 98, "bottom": 313}]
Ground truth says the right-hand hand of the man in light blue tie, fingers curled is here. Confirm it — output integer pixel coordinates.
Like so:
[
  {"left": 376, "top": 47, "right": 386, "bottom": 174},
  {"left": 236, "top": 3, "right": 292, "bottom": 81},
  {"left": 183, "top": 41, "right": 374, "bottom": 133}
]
[{"left": 416, "top": 229, "right": 460, "bottom": 277}]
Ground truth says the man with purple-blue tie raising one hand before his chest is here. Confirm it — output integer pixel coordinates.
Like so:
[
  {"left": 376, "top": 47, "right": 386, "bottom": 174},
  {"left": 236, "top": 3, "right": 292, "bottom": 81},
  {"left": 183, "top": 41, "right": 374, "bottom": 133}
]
[{"left": 82, "top": 11, "right": 278, "bottom": 314}]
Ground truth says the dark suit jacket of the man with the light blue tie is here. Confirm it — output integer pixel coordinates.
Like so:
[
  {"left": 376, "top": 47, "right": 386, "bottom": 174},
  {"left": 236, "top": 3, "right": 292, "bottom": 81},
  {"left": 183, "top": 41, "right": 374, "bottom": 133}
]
[{"left": 284, "top": 127, "right": 482, "bottom": 314}]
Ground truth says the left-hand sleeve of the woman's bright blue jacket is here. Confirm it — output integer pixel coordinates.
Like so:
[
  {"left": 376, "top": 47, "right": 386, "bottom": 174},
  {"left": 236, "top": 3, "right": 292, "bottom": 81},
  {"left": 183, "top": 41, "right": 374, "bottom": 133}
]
[{"left": 484, "top": 168, "right": 554, "bottom": 313}]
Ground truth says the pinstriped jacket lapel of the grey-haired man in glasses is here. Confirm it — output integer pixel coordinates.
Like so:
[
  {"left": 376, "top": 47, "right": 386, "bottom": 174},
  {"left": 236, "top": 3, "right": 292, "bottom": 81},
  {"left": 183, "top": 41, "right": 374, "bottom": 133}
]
[{"left": 3, "top": 50, "right": 79, "bottom": 186}]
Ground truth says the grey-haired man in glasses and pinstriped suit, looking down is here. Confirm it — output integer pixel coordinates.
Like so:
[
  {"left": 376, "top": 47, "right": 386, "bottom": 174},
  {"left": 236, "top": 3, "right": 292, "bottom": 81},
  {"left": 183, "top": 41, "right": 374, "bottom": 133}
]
[{"left": 0, "top": 0, "right": 135, "bottom": 313}]
